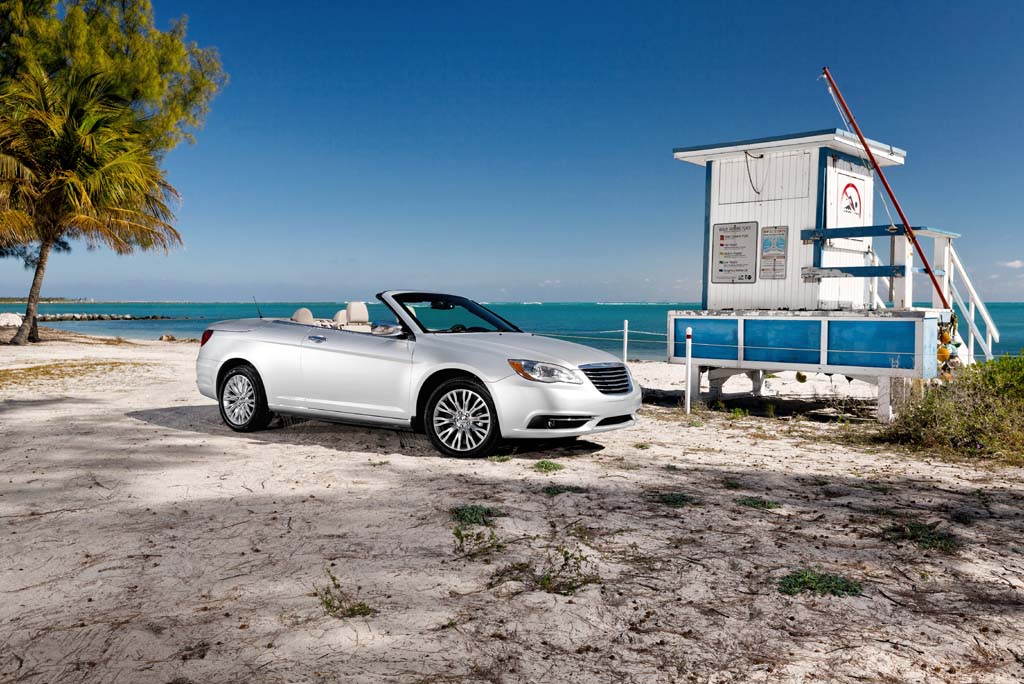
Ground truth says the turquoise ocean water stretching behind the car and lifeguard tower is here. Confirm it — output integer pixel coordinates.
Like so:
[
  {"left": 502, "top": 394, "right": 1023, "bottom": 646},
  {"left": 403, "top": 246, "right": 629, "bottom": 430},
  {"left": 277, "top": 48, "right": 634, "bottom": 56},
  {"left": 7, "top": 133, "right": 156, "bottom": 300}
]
[{"left": 0, "top": 302, "right": 1024, "bottom": 359}]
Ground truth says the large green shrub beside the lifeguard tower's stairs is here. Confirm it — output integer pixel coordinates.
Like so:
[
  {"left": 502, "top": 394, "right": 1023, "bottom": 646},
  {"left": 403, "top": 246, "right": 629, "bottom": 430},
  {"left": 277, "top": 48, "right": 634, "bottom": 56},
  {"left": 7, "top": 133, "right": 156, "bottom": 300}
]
[{"left": 882, "top": 356, "right": 1024, "bottom": 461}]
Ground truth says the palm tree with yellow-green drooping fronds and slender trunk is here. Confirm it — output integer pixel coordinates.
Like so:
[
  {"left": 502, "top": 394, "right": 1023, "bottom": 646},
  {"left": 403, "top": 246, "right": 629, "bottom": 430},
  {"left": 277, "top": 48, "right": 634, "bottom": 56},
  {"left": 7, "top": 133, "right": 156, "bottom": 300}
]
[{"left": 0, "top": 66, "right": 181, "bottom": 344}]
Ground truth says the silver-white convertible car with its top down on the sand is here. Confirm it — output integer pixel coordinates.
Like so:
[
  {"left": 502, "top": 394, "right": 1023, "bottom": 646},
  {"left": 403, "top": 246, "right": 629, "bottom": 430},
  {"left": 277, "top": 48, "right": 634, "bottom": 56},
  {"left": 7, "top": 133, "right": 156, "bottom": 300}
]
[{"left": 196, "top": 291, "right": 640, "bottom": 457}]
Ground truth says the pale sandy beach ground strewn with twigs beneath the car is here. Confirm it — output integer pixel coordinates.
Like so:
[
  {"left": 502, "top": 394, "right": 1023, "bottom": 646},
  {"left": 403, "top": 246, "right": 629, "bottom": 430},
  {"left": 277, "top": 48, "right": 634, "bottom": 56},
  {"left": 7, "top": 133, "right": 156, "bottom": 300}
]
[{"left": 0, "top": 330, "right": 1024, "bottom": 684}]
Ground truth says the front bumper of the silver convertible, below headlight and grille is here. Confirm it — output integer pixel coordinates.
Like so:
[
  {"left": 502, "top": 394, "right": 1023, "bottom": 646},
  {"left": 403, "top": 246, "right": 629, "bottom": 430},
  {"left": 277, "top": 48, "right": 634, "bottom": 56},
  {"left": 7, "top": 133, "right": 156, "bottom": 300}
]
[{"left": 487, "top": 375, "right": 641, "bottom": 439}]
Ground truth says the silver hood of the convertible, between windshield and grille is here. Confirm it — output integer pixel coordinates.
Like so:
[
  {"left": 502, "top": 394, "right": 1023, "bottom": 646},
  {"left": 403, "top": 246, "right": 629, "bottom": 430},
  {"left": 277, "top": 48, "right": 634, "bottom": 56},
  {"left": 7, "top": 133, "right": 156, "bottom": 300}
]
[{"left": 431, "top": 333, "right": 621, "bottom": 367}]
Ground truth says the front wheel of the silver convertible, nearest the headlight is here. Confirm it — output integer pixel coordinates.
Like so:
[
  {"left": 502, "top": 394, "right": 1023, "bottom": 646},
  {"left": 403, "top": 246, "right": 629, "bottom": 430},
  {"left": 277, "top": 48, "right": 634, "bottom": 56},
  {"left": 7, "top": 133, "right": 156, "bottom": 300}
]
[{"left": 423, "top": 378, "right": 502, "bottom": 459}]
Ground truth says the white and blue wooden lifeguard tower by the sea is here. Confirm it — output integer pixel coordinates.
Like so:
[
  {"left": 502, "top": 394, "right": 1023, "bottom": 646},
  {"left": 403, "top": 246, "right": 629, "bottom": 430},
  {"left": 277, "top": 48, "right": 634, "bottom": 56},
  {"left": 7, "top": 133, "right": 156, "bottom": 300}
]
[{"left": 669, "top": 129, "right": 998, "bottom": 421}]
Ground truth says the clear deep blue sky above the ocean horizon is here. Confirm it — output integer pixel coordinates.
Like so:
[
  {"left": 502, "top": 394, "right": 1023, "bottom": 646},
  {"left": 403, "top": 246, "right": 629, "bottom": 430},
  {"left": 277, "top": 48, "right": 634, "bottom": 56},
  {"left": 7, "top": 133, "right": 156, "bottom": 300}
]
[{"left": 0, "top": 0, "right": 1024, "bottom": 301}]
